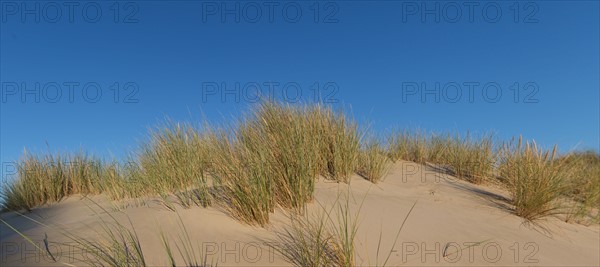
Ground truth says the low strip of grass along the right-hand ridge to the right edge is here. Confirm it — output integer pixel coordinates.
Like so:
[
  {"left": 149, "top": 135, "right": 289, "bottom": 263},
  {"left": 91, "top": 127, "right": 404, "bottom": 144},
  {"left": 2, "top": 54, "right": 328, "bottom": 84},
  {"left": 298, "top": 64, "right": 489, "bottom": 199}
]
[{"left": 387, "top": 130, "right": 600, "bottom": 223}]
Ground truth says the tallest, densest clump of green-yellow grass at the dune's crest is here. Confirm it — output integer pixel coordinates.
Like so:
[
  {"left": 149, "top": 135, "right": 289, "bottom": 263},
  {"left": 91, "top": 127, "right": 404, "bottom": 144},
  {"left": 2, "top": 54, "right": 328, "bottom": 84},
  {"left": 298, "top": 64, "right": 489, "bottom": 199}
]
[{"left": 209, "top": 102, "right": 359, "bottom": 226}]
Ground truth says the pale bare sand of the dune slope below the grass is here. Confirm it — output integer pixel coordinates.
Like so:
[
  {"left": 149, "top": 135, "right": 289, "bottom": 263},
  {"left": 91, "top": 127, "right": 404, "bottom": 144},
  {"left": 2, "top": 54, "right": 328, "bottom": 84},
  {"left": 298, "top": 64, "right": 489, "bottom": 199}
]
[{"left": 0, "top": 162, "right": 600, "bottom": 266}]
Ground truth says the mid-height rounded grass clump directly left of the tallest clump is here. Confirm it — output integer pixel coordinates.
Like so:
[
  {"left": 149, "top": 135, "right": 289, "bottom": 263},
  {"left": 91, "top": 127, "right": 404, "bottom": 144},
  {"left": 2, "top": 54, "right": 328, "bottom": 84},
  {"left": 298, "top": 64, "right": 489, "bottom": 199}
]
[{"left": 138, "top": 122, "right": 210, "bottom": 207}]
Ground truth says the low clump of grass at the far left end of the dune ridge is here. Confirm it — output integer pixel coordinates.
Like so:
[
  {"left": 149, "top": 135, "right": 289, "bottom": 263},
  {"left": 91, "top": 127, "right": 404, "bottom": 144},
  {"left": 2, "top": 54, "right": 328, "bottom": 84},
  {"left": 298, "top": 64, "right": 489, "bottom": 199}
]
[{"left": 0, "top": 153, "right": 109, "bottom": 214}]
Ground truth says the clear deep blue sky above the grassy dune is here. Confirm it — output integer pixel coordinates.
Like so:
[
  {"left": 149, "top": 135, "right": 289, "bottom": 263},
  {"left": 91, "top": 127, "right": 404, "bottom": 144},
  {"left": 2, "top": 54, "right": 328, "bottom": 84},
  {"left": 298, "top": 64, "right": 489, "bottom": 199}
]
[{"left": 0, "top": 1, "right": 600, "bottom": 178}]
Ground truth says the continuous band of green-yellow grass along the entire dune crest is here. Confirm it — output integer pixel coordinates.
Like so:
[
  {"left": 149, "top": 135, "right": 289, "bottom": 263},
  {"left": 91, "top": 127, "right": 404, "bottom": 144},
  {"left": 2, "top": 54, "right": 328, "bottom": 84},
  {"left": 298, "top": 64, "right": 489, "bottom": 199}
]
[{"left": 0, "top": 101, "right": 600, "bottom": 226}]
